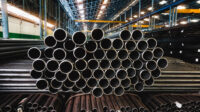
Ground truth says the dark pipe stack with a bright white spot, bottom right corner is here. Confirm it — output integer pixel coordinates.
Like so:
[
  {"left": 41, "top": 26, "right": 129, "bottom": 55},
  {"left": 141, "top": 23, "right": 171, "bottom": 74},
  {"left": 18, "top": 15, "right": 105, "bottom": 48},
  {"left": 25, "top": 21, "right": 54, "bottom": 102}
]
[{"left": 145, "top": 94, "right": 200, "bottom": 112}]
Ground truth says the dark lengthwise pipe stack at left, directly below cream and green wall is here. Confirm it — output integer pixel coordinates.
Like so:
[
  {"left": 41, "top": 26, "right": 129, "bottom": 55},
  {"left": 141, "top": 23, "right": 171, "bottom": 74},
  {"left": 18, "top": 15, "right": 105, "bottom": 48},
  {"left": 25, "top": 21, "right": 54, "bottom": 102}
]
[{"left": 0, "top": 39, "right": 43, "bottom": 59}]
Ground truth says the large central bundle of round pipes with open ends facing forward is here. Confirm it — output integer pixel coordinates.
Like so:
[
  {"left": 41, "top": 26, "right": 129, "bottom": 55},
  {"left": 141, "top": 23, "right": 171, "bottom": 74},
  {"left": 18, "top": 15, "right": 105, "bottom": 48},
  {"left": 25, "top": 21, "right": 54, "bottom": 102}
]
[{"left": 28, "top": 29, "right": 167, "bottom": 97}]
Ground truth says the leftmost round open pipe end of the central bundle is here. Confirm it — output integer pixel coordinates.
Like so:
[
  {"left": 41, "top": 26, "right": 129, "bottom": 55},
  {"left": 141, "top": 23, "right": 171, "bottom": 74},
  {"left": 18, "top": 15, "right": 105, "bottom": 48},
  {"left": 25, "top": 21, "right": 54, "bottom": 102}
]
[{"left": 27, "top": 47, "right": 42, "bottom": 60}]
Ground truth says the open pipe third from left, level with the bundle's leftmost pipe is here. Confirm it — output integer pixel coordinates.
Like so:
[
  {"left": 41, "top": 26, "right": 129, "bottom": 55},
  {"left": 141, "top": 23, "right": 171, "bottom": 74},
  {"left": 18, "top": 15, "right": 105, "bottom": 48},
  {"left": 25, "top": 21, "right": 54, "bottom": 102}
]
[{"left": 53, "top": 48, "right": 67, "bottom": 61}]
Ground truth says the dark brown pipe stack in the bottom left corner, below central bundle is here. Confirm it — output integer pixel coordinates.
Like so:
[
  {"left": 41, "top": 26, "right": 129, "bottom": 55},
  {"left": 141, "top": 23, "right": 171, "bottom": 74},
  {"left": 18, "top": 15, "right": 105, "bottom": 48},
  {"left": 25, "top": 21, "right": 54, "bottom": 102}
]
[{"left": 0, "top": 94, "right": 63, "bottom": 112}]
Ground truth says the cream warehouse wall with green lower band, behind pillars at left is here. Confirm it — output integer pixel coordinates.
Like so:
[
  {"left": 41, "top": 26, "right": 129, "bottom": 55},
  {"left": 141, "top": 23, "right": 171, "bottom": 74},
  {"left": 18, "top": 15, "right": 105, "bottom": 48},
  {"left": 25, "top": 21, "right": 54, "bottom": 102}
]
[{"left": 0, "top": 16, "right": 52, "bottom": 39}]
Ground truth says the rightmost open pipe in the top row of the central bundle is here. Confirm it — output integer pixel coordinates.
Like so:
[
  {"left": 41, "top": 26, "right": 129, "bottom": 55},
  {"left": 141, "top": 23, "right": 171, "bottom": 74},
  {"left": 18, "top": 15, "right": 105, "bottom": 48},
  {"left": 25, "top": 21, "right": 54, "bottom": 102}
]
[{"left": 131, "top": 29, "right": 144, "bottom": 41}]
